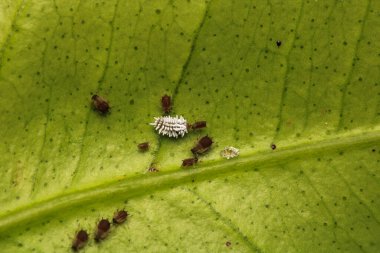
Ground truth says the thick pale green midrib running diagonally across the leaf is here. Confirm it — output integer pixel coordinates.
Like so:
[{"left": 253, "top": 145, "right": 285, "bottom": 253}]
[{"left": 0, "top": 128, "right": 380, "bottom": 233}]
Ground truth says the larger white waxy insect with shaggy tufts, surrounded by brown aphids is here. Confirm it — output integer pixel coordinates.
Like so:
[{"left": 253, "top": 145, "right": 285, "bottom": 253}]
[{"left": 150, "top": 115, "right": 187, "bottom": 138}]
